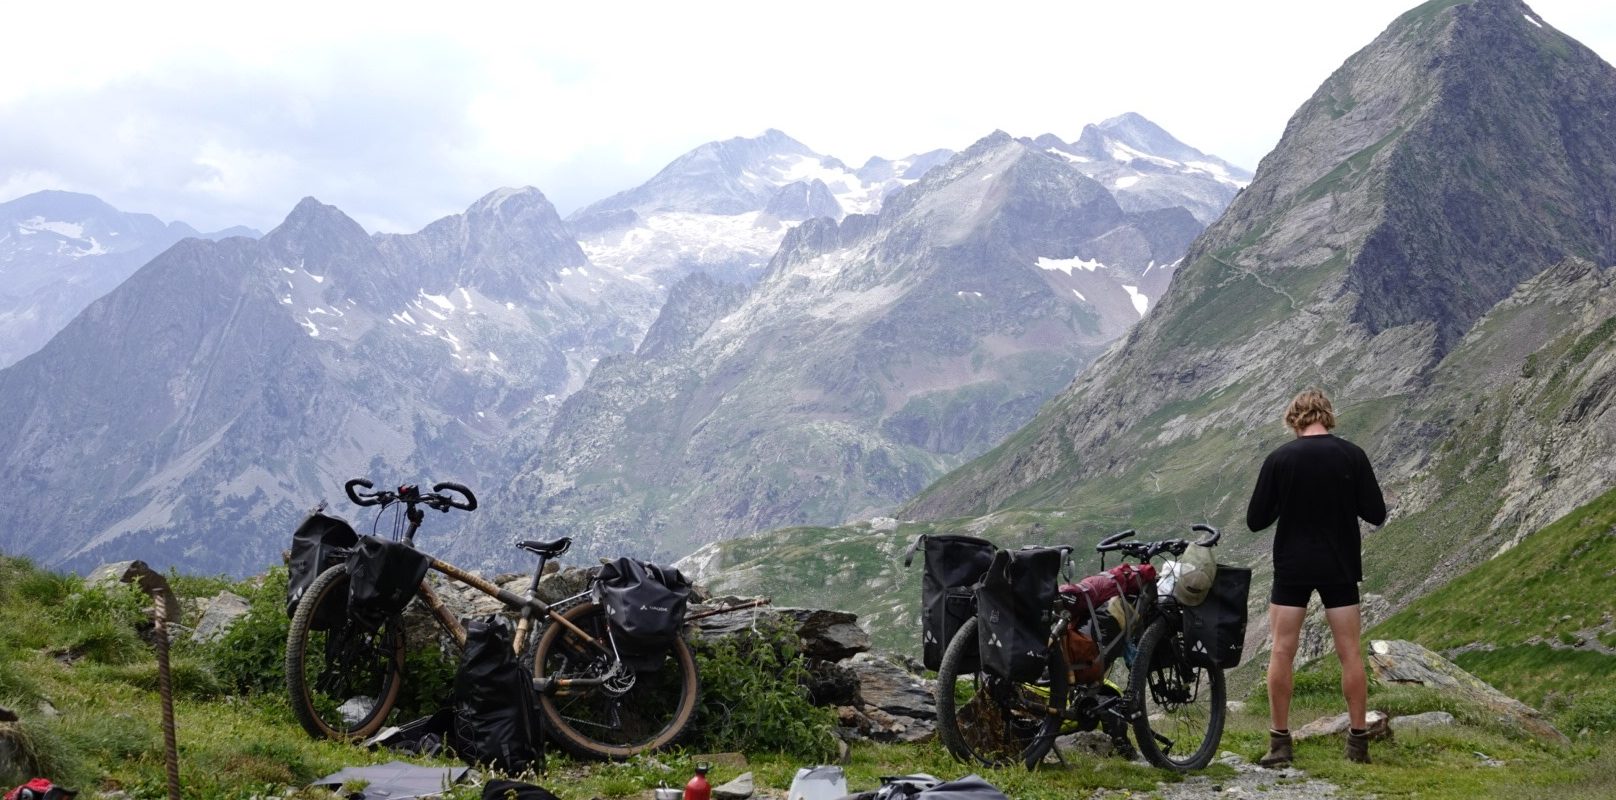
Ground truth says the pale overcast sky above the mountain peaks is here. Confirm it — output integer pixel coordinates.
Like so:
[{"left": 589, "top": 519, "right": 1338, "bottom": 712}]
[{"left": 0, "top": 0, "right": 1616, "bottom": 231}]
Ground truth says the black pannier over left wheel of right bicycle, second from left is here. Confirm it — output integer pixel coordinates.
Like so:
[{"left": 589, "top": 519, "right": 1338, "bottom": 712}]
[{"left": 976, "top": 548, "right": 1065, "bottom": 680}]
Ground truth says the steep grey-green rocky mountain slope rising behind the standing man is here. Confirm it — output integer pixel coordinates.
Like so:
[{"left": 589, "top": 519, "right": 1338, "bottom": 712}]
[{"left": 687, "top": 0, "right": 1616, "bottom": 652}]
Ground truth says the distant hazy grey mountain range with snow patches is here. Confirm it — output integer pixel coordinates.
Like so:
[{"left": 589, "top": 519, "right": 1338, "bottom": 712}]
[{"left": 0, "top": 118, "right": 1238, "bottom": 574}]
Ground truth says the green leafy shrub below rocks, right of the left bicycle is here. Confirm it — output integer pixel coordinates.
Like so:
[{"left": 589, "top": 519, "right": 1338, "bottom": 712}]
[{"left": 690, "top": 629, "right": 835, "bottom": 760}]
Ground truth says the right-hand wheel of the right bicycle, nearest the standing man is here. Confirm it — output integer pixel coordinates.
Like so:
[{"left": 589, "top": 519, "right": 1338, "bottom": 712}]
[{"left": 1128, "top": 619, "right": 1225, "bottom": 773}]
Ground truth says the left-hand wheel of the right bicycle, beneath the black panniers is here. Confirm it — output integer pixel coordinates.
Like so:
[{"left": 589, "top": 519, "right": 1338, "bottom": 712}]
[{"left": 936, "top": 617, "right": 1068, "bottom": 769}]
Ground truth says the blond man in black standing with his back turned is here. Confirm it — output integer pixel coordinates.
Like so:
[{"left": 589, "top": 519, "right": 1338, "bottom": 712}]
[{"left": 1246, "top": 389, "right": 1387, "bottom": 766}]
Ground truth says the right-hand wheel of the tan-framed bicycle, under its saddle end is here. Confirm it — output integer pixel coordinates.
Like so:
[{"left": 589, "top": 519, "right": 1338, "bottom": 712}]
[{"left": 533, "top": 603, "right": 700, "bottom": 760}]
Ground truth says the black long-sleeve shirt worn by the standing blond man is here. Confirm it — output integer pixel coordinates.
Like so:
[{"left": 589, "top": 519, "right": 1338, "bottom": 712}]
[{"left": 1246, "top": 433, "right": 1387, "bottom": 585}]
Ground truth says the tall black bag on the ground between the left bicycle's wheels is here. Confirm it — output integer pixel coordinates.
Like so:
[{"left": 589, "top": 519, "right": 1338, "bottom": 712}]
[{"left": 449, "top": 616, "right": 545, "bottom": 774}]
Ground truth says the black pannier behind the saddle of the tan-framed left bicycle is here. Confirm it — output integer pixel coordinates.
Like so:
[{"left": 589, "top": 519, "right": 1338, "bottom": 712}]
[{"left": 591, "top": 558, "right": 690, "bottom": 672}]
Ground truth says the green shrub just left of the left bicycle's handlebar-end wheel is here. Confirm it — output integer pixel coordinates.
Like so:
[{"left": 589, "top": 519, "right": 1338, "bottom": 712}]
[{"left": 205, "top": 567, "right": 291, "bottom": 692}]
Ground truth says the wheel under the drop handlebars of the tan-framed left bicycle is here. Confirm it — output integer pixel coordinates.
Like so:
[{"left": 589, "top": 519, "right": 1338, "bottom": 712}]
[{"left": 286, "top": 564, "right": 404, "bottom": 739}]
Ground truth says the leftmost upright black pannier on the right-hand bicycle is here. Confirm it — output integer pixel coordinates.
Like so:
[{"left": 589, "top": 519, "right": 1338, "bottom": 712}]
[{"left": 903, "top": 533, "right": 997, "bottom": 671}]
